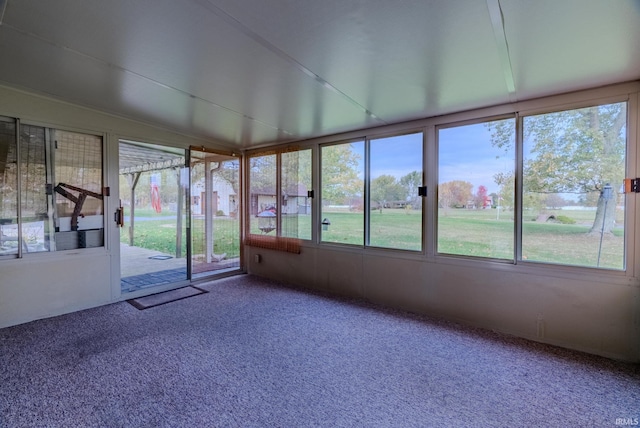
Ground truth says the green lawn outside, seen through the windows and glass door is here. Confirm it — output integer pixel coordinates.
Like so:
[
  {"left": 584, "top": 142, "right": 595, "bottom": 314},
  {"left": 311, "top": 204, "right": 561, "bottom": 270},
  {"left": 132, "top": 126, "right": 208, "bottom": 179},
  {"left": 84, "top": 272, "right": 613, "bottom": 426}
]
[{"left": 121, "top": 209, "right": 624, "bottom": 269}]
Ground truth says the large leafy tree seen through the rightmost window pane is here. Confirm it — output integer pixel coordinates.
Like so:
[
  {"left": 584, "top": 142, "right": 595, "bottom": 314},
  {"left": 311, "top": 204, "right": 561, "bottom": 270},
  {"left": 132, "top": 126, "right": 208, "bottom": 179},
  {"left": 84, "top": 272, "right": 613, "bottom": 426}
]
[{"left": 489, "top": 103, "right": 627, "bottom": 233}]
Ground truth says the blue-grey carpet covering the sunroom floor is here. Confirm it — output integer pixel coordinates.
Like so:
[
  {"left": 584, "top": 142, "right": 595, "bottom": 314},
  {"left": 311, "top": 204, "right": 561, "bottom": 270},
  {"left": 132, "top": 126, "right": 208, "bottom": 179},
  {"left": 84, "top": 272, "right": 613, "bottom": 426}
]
[{"left": 0, "top": 275, "right": 640, "bottom": 428}]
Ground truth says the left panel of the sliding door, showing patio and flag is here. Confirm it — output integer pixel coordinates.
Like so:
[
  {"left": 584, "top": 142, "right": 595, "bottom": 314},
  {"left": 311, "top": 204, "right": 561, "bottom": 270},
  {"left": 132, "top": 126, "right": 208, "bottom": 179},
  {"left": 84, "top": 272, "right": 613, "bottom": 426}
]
[{"left": 119, "top": 140, "right": 189, "bottom": 293}]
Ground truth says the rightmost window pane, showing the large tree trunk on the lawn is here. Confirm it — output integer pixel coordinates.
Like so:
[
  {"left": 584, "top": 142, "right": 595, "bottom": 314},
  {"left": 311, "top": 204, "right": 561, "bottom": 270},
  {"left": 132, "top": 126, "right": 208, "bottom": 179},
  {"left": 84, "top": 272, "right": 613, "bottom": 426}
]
[{"left": 522, "top": 103, "right": 627, "bottom": 269}]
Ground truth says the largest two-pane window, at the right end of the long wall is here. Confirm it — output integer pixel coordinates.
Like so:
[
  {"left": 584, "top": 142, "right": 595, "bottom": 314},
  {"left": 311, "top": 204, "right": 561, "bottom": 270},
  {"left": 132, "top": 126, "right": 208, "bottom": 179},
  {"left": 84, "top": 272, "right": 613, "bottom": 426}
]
[{"left": 437, "top": 102, "right": 627, "bottom": 270}]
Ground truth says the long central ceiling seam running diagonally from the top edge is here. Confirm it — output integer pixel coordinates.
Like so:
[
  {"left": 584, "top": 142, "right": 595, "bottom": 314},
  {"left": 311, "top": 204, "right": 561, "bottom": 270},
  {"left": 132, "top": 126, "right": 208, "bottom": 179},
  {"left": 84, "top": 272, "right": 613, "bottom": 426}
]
[{"left": 196, "top": 0, "right": 388, "bottom": 125}]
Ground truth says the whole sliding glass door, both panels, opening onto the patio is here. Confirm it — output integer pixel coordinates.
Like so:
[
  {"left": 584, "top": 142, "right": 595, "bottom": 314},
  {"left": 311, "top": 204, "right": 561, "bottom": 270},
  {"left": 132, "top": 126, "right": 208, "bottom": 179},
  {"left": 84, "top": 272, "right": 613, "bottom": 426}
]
[{"left": 116, "top": 140, "right": 241, "bottom": 293}]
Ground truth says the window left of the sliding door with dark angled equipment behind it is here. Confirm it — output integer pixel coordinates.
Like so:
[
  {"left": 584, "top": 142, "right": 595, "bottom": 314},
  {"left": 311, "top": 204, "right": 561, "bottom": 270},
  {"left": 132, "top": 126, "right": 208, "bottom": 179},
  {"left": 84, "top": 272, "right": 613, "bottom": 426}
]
[{"left": 0, "top": 117, "right": 104, "bottom": 255}]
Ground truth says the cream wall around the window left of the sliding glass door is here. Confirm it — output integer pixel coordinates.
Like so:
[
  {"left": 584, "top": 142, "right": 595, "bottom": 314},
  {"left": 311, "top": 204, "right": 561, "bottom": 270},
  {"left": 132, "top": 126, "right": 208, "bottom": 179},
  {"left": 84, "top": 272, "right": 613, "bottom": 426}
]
[{"left": 0, "top": 86, "right": 230, "bottom": 328}]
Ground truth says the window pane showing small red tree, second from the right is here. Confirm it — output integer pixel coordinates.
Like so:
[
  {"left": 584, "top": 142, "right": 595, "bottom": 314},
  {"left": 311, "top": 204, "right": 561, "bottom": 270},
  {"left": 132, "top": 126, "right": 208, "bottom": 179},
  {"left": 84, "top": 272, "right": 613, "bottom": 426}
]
[{"left": 438, "top": 119, "right": 515, "bottom": 260}]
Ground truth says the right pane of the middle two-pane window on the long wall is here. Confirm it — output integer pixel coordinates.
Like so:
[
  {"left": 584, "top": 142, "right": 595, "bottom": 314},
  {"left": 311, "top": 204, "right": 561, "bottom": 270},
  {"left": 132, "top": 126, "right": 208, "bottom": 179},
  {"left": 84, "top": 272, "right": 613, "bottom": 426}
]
[{"left": 369, "top": 133, "right": 422, "bottom": 251}]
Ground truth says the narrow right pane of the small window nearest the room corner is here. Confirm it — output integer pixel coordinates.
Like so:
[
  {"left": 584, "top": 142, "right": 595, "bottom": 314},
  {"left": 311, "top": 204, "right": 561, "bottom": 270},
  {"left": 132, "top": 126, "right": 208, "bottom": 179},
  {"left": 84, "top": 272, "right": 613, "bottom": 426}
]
[{"left": 281, "top": 150, "right": 311, "bottom": 239}]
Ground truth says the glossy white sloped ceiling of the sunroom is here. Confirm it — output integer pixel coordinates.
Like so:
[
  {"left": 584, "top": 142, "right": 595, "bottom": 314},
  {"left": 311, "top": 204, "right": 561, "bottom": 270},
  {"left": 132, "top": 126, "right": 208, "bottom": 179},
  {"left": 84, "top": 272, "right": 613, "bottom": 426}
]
[{"left": 0, "top": 0, "right": 640, "bottom": 148}]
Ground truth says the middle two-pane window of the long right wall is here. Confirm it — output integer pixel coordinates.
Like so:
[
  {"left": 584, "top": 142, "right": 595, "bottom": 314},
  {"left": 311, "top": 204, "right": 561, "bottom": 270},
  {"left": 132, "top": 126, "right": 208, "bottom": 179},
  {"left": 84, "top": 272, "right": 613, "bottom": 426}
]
[{"left": 320, "top": 132, "right": 424, "bottom": 251}]
